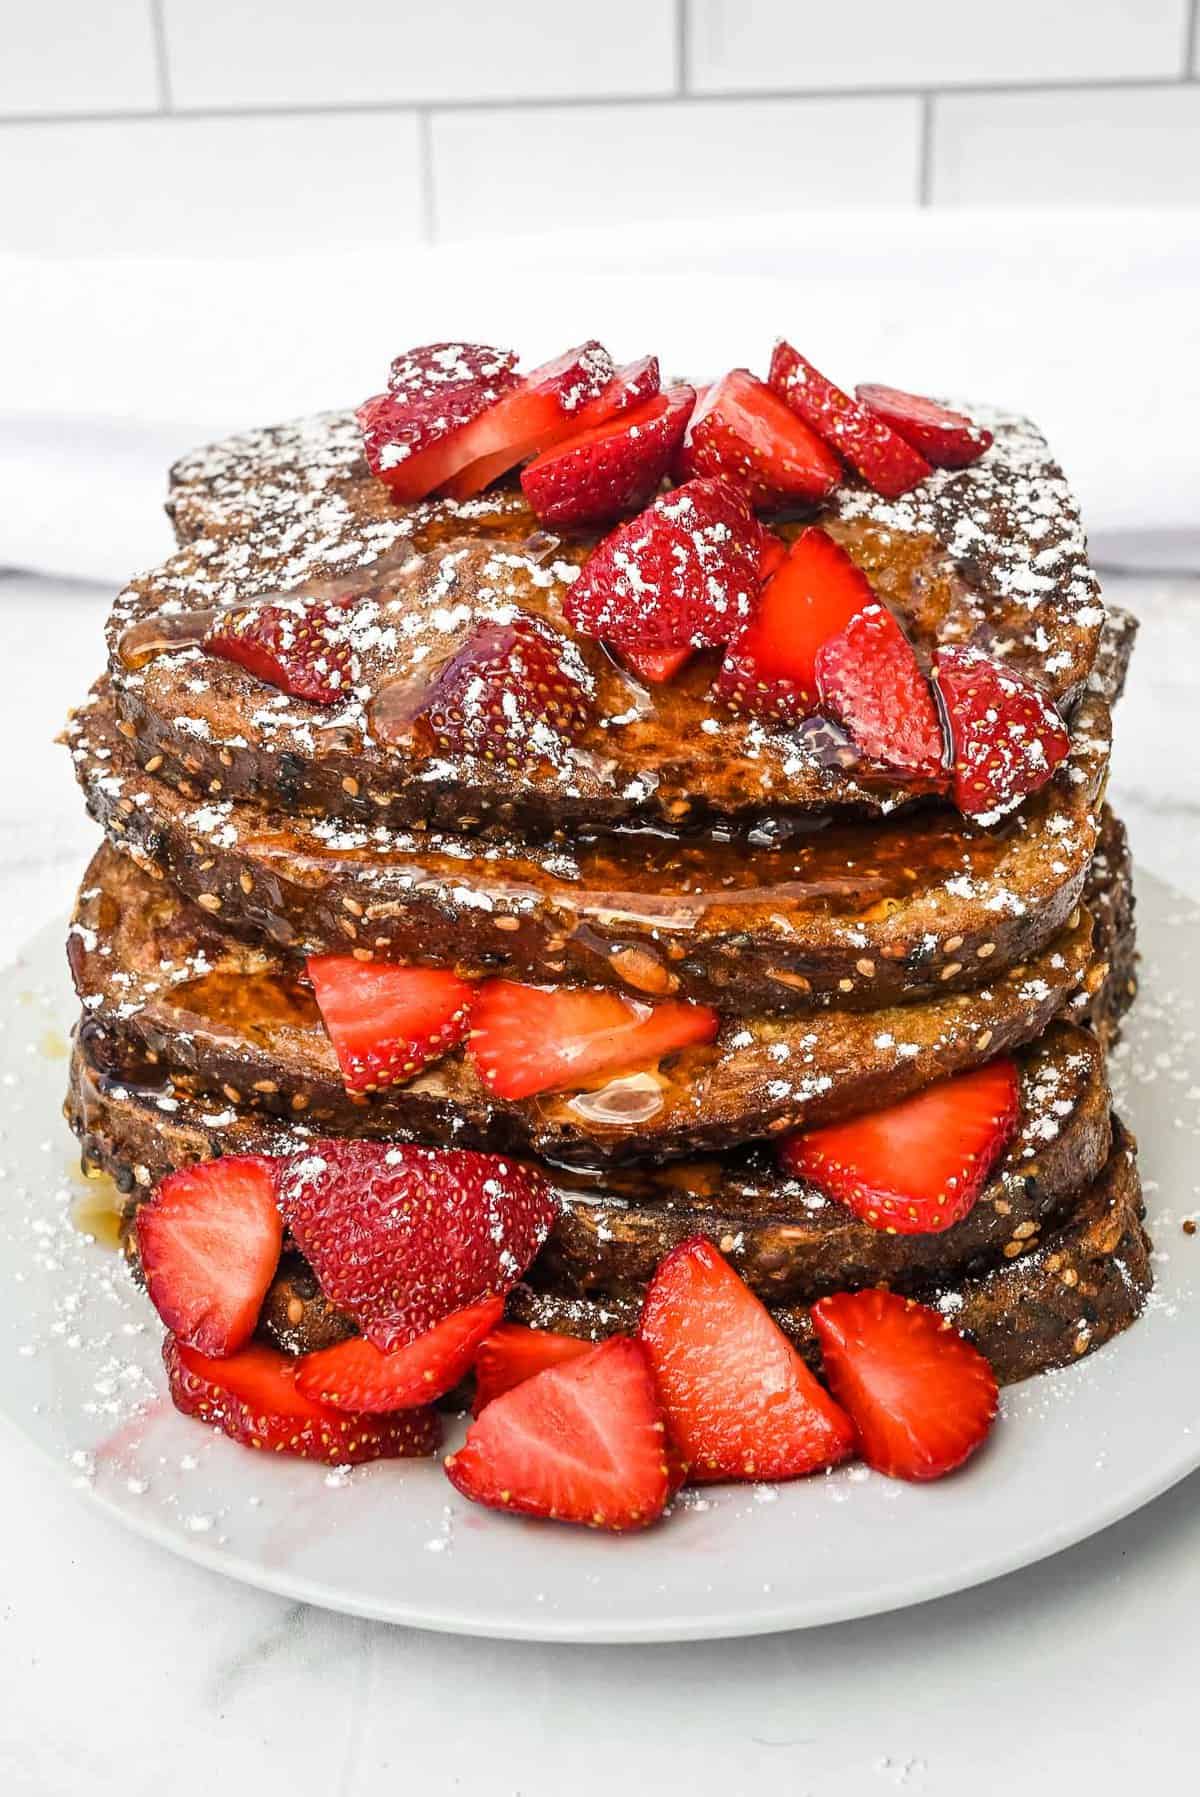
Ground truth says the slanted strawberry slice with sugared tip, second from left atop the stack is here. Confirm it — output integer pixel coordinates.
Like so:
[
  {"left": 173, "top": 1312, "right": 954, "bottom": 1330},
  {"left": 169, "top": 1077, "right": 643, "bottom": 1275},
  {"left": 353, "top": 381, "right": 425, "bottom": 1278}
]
[{"left": 444, "top": 340, "right": 623, "bottom": 500}]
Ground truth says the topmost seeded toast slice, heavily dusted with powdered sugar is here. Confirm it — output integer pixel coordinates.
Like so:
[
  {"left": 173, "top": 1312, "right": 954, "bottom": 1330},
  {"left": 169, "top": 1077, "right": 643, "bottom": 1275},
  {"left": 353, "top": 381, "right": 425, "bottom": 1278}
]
[{"left": 100, "top": 408, "right": 1105, "bottom": 834}]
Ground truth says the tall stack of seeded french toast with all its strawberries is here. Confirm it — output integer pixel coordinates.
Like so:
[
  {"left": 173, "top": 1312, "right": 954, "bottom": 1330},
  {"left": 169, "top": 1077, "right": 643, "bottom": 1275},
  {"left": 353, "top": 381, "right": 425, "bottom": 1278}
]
[{"left": 66, "top": 341, "right": 1151, "bottom": 1527}]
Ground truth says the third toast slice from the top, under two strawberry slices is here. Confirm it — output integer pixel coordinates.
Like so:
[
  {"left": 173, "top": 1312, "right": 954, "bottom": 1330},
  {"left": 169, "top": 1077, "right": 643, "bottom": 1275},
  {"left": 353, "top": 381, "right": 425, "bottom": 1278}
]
[{"left": 68, "top": 845, "right": 1107, "bottom": 1164}]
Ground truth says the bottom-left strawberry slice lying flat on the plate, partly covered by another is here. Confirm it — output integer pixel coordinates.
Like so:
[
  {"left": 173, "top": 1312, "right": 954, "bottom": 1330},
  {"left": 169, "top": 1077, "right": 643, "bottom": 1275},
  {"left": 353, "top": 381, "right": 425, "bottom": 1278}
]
[{"left": 162, "top": 1335, "right": 442, "bottom": 1466}]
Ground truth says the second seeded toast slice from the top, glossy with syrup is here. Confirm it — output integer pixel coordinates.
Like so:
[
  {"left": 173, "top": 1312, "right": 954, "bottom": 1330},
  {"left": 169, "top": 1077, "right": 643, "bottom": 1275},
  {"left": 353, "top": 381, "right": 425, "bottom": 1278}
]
[{"left": 66, "top": 688, "right": 1110, "bottom": 1015}]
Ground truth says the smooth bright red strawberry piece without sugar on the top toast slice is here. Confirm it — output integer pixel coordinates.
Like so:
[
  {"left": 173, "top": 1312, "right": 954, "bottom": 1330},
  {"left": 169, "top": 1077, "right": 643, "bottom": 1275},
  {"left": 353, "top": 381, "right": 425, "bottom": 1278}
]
[{"left": 717, "top": 525, "right": 875, "bottom": 722}]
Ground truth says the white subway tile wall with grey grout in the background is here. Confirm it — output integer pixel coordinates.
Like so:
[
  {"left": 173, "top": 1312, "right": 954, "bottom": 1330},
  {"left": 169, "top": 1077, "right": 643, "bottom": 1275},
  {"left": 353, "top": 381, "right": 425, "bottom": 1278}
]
[{"left": 0, "top": 0, "right": 1200, "bottom": 255}]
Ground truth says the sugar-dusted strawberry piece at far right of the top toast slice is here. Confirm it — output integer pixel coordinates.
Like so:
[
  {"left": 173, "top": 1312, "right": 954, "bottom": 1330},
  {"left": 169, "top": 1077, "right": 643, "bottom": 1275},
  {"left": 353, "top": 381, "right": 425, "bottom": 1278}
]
[{"left": 934, "top": 649, "right": 1071, "bottom": 823}]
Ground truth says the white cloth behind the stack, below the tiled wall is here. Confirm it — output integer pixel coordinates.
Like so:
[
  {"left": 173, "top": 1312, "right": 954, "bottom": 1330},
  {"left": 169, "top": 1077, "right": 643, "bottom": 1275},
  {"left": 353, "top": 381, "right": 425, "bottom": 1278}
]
[{"left": 0, "top": 210, "right": 1200, "bottom": 582}]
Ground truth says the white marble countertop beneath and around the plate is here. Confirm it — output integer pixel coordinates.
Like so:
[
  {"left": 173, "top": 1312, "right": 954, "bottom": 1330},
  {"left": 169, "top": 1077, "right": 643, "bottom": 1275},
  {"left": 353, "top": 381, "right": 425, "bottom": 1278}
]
[{"left": 0, "top": 577, "right": 1200, "bottom": 1797}]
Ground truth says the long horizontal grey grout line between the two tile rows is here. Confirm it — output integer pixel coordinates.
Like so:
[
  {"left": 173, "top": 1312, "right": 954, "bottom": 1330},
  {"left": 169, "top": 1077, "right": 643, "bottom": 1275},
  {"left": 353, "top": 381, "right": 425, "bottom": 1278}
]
[{"left": 0, "top": 71, "right": 1200, "bottom": 129}]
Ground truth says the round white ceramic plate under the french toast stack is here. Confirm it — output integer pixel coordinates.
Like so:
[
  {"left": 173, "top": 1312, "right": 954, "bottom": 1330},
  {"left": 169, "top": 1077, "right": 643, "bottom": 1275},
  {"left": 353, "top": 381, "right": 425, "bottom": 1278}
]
[{"left": 0, "top": 879, "right": 1200, "bottom": 1641}]
